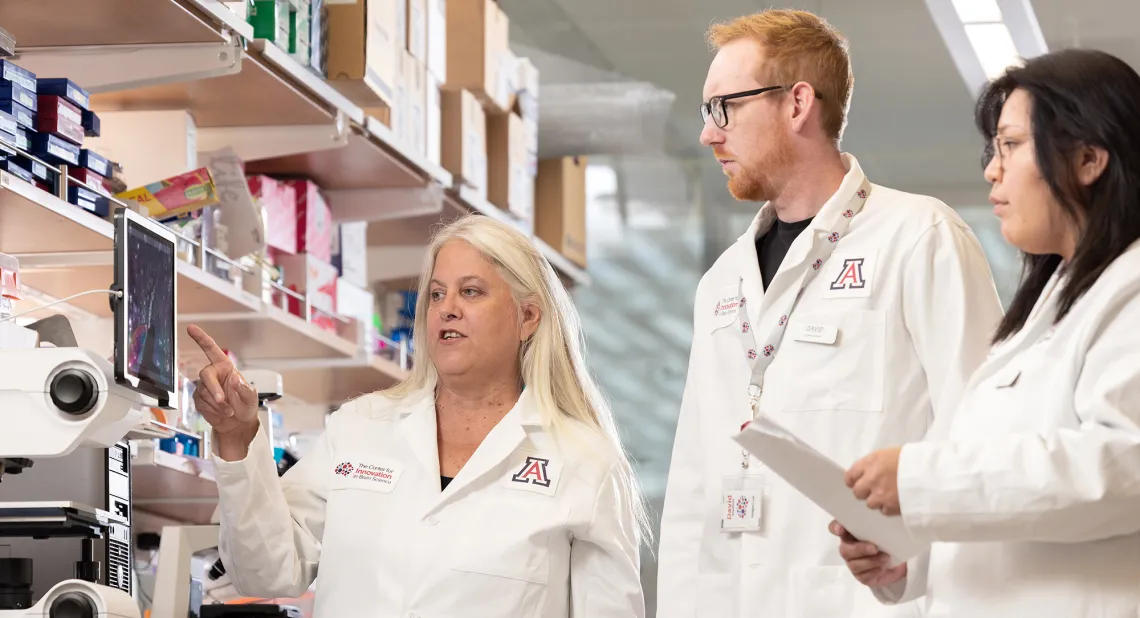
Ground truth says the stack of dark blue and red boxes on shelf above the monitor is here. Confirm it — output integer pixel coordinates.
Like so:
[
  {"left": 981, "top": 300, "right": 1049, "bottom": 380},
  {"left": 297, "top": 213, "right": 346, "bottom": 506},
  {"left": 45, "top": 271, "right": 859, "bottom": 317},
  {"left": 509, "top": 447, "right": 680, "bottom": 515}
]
[{"left": 0, "top": 60, "right": 111, "bottom": 217}]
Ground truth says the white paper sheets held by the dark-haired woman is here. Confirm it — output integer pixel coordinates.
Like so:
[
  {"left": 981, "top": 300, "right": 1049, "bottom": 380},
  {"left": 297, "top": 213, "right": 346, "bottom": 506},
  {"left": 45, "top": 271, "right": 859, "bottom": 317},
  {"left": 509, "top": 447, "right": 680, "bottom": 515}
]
[{"left": 734, "top": 416, "right": 926, "bottom": 566}]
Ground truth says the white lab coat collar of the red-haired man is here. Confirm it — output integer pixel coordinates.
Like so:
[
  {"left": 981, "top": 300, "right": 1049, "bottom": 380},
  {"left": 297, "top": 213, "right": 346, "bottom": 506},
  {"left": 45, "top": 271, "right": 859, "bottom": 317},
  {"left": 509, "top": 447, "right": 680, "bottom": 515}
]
[{"left": 735, "top": 153, "right": 873, "bottom": 323}]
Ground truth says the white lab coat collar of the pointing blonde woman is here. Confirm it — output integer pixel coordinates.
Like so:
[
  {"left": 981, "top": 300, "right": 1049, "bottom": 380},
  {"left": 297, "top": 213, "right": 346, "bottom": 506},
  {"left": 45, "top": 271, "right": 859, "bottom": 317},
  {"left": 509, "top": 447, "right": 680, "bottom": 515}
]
[{"left": 387, "top": 383, "right": 545, "bottom": 515}]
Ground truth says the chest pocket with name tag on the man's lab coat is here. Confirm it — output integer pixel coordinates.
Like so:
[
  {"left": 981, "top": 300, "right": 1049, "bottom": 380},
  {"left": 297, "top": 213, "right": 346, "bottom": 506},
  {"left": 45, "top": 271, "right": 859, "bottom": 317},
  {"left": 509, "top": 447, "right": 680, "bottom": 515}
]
[{"left": 764, "top": 309, "right": 887, "bottom": 412}]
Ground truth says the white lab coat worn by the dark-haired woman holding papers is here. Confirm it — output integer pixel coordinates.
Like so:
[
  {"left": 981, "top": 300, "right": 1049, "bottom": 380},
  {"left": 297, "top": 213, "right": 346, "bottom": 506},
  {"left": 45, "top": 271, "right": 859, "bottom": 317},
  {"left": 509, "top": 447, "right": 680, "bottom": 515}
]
[{"left": 878, "top": 243, "right": 1140, "bottom": 618}]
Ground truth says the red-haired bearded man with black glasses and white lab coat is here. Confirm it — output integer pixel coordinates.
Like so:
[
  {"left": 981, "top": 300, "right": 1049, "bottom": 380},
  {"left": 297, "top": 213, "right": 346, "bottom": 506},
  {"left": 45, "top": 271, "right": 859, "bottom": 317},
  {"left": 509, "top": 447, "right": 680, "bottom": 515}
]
[{"left": 657, "top": 10, "right": 1001, "bottom": 618}]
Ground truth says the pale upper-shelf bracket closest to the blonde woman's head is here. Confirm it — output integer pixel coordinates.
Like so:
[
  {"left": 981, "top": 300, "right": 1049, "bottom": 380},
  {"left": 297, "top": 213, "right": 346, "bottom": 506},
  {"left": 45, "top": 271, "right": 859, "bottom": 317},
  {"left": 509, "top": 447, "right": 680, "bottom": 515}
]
[{"left": 325, "top": 182, "right": 443, "bottom": 222}]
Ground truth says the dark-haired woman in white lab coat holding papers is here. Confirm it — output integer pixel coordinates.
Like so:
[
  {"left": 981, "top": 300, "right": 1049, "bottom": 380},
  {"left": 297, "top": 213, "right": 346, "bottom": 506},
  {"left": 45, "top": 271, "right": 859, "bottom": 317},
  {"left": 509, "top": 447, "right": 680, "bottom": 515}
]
[{"left": 832, "top": 50, "right": 1140, "bottom": 618}]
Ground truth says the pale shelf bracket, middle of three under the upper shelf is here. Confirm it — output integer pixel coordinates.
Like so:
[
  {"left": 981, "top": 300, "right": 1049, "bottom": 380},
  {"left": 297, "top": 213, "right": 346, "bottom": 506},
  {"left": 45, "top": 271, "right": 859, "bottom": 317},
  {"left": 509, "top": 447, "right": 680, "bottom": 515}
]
[{"left": 198, "top": 111, "right": 349, "bottom": 162}]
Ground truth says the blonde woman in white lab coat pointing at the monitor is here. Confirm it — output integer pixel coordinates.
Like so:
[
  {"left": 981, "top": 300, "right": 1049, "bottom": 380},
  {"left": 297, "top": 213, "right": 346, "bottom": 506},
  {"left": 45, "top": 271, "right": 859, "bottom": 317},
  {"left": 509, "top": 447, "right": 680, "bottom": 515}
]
[{"left": 189, "top": 216, "right": 645, "bottom": 618}]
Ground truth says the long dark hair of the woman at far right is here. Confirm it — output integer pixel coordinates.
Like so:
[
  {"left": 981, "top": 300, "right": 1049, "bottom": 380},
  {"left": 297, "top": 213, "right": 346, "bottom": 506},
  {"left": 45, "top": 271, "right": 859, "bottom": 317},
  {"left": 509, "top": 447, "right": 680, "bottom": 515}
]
[{"left": 975, "top": 49, "right": 1140, "bottom": 342}]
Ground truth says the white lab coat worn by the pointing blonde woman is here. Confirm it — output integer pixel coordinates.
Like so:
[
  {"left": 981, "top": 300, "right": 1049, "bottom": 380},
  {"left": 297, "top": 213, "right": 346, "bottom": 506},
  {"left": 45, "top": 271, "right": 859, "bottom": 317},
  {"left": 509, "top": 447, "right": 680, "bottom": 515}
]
[{"left": 214, "top": 389, "right": 644, "bottom": 618}]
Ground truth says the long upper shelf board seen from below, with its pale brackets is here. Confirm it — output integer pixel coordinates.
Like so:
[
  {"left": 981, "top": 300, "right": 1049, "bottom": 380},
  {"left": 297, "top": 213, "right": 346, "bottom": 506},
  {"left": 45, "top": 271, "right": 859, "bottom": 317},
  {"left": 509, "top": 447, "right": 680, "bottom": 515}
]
[{"left": 0, "top": 0, "right": 588, "bottom": 284}]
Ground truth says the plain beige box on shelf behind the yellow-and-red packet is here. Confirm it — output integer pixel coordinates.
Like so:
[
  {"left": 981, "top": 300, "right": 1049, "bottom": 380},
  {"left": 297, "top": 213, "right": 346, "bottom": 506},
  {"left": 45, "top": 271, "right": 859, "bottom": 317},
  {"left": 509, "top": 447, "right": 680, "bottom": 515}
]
[{"left": 84, "top": 109, "right": 198, "bottom": 187}]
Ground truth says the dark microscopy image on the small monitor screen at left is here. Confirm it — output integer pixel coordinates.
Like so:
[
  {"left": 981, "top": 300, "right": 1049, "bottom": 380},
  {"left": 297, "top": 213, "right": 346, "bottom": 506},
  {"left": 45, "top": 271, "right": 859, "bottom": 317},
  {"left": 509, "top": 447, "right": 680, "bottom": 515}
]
[{"left": 125, "top": 221, "right": 174, "bottom": 391}]
